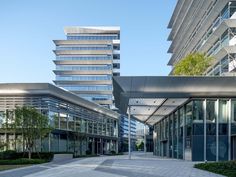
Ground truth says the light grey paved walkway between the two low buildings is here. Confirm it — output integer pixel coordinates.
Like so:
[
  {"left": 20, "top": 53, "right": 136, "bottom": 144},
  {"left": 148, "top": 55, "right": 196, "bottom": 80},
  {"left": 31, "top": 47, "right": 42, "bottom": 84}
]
[{"left": 0, "top": 153, "right": 222, "bottom": 177}]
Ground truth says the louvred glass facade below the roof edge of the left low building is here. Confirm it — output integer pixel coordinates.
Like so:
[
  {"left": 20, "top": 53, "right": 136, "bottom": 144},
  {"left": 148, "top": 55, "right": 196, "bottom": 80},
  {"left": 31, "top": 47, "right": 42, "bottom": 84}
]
[{"left": 0, "top": 96, "right": 118, "bottom": 155}]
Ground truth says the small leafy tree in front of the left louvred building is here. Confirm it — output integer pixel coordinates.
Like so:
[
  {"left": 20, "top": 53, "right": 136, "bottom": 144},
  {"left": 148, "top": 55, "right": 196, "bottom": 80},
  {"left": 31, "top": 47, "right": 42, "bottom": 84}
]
[{"left": 13, "top": 106, "right": 51, "bottom": 159}]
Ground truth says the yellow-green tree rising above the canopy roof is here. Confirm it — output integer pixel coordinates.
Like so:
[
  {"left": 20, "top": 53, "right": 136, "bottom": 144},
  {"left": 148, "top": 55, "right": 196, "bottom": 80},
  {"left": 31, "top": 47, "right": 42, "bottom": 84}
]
[{"left": 173, "top": 53, "right": 212, "bottom": 76}]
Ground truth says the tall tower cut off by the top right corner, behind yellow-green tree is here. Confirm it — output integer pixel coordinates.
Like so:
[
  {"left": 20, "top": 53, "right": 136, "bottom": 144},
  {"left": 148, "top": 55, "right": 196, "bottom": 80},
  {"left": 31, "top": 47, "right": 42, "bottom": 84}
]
[{"left": 168, "top": 0, "right": 236, "bottom": 76}]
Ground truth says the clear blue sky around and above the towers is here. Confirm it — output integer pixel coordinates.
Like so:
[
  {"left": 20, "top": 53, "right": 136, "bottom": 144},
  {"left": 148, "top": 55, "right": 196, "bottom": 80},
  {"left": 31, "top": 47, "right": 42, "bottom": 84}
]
[{"left": 0, "top": 0, "right": 176, "bottom": 82}]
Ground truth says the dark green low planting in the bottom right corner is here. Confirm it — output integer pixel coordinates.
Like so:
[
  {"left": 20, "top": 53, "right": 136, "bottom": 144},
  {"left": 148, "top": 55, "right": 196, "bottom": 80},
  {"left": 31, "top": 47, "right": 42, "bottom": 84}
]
[{"left": 194, "top": 161, "right": 236, "bottom": 177}]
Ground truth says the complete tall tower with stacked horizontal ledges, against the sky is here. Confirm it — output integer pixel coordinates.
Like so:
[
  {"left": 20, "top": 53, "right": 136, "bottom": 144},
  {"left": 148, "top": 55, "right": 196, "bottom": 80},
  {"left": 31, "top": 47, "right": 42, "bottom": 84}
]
[{"left": 54, "top": 27, "right": 120, "bottom": 108}]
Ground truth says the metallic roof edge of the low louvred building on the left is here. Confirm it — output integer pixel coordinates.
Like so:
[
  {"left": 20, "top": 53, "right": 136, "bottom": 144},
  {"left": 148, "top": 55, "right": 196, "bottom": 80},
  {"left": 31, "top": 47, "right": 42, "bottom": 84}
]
[{"left": 0, "top": 83, "right": 120, "bottom": 119}]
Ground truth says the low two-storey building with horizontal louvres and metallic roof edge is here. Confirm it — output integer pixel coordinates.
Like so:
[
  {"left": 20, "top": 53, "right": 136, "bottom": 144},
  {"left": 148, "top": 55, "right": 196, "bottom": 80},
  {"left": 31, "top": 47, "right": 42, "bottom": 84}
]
[{"left": 0, "top": 83, "right": 119, "bottom": 155}]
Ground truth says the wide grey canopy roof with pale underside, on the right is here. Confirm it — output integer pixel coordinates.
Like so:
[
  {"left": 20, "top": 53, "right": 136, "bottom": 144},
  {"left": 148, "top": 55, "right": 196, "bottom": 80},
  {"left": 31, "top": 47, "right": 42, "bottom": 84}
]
[{"left": 113, "top": 76, "right": 236, "bottom": 125}]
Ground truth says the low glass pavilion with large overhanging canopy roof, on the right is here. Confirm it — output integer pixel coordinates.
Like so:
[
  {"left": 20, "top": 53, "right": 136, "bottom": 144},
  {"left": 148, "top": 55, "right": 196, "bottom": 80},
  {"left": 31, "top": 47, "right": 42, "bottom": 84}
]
[{"left": 113, "top": 76, "right": 236, "bottom": 161}]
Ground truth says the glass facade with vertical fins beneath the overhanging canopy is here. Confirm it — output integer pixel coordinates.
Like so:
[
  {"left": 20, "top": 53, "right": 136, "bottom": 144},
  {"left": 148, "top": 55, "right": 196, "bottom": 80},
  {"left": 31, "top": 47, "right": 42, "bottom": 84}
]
[{"left": 153, "top": 98, "right": 236, "bottom": 161}]
